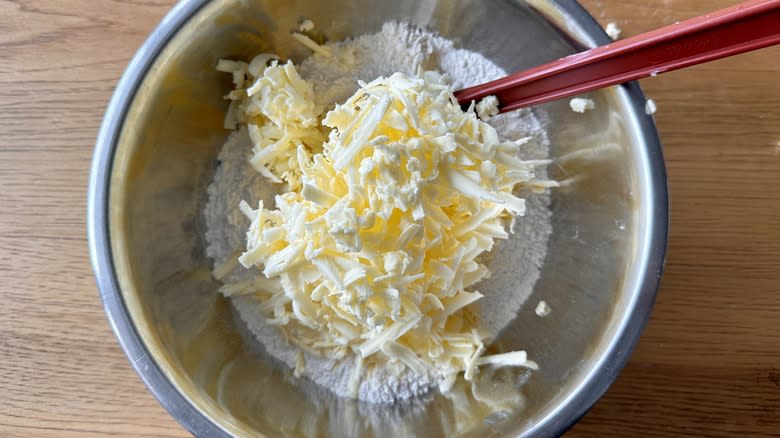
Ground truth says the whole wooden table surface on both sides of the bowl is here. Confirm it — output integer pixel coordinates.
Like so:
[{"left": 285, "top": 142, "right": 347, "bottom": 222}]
[{"left": 0, "top": 0, "right": 780, "bottom": 437}]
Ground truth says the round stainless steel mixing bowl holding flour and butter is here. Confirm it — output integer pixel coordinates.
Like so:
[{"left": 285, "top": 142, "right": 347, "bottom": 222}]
[{"left": 89, "top": 0, "right": 667, "bottom": 436}]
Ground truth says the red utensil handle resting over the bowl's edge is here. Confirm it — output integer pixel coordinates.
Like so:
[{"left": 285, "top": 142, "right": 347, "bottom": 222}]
[{"left": 455, "top": 0, "right": 780, "bottom": 112}]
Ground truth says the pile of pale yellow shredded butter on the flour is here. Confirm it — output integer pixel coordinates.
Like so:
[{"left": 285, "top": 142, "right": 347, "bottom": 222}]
[{"left": 217, "top": 55, "right": 549, "bottom": 396}]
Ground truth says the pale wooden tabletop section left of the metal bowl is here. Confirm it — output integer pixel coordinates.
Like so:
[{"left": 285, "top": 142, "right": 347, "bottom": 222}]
[{"left": 0, "top": 0, "right": 187, "bottom": 437}]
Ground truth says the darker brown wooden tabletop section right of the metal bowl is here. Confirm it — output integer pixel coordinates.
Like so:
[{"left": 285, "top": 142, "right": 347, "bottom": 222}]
[{"left": 569, "top": 0, "right": 780, "bottom": 437}]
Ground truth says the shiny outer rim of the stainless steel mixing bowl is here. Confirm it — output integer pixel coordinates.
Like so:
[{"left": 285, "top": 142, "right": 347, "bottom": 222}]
[{"left": 87, "top": 0, "right": 669, "bottom": 437}]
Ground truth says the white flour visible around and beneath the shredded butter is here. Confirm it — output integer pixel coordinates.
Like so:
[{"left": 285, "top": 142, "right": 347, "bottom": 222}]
[{"left": 204, "top": 23, "right": 551, "bottom": 403}]
